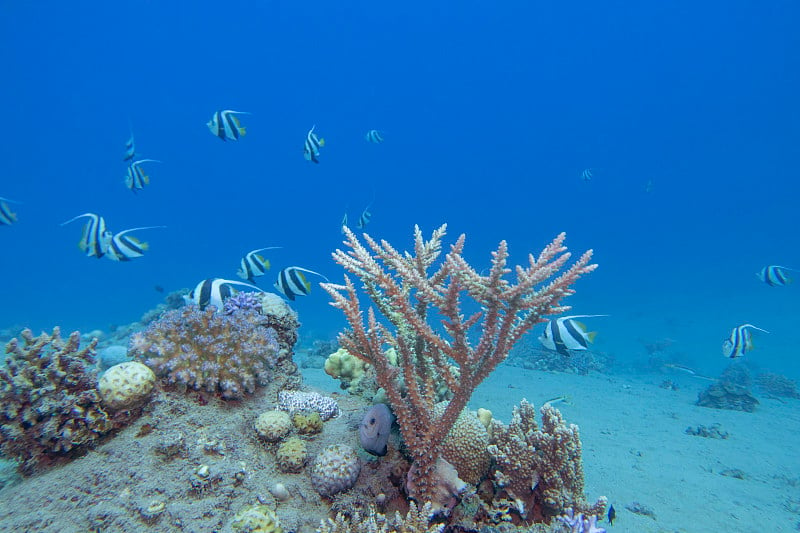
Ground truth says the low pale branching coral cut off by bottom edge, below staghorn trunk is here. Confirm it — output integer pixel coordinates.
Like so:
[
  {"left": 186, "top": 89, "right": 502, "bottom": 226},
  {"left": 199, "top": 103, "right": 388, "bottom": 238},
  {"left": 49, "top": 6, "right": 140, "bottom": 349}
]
[{"left": 317, "top": 502, "right": 444, "bottom": 533}]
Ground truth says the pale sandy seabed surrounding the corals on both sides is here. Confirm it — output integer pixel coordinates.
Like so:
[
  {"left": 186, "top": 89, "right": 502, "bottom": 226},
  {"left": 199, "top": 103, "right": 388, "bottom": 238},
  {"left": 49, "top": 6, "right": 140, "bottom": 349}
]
[{"left": 0, "top": 365, "right": 800, "bottom": 533}]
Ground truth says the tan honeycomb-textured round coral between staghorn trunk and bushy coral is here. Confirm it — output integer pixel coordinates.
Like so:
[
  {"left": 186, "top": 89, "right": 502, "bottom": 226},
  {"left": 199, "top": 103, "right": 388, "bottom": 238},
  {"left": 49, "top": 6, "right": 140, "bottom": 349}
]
[{"left": 434, "top": 402, "right": 492, "bottom": 485}]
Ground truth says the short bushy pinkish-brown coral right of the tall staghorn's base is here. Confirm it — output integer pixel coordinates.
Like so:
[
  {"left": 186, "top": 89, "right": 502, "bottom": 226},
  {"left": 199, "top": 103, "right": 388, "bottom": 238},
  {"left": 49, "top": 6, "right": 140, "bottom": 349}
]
[{"left": 489, "top": 399, "right": 605, "bottom": 522}]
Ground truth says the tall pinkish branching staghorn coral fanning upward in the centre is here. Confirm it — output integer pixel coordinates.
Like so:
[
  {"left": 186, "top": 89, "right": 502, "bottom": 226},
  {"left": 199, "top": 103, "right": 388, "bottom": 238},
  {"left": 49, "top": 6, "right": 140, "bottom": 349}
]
[{"left": 322, "top": 226, "right": 596, "bottom": 507}]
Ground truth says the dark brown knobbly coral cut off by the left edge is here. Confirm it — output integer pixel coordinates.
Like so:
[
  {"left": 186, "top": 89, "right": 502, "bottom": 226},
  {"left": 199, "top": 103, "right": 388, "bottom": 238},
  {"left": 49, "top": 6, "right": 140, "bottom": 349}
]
[{"left": 0, "top": 327, "right": 133, "bottom": 474}]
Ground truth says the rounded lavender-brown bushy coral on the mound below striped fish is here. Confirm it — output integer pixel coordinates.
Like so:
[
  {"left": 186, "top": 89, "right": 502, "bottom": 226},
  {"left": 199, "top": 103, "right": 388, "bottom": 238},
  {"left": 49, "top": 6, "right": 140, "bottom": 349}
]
[{"left": 130, "top": 305, "right": 280, "bottom": 399}]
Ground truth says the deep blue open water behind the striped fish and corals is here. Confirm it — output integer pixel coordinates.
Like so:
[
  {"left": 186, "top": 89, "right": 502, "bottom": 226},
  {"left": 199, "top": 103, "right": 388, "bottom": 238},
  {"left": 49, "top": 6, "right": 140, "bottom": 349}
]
[{"left": 0, "top": 0, "right": 800, "bottom": 378}]
